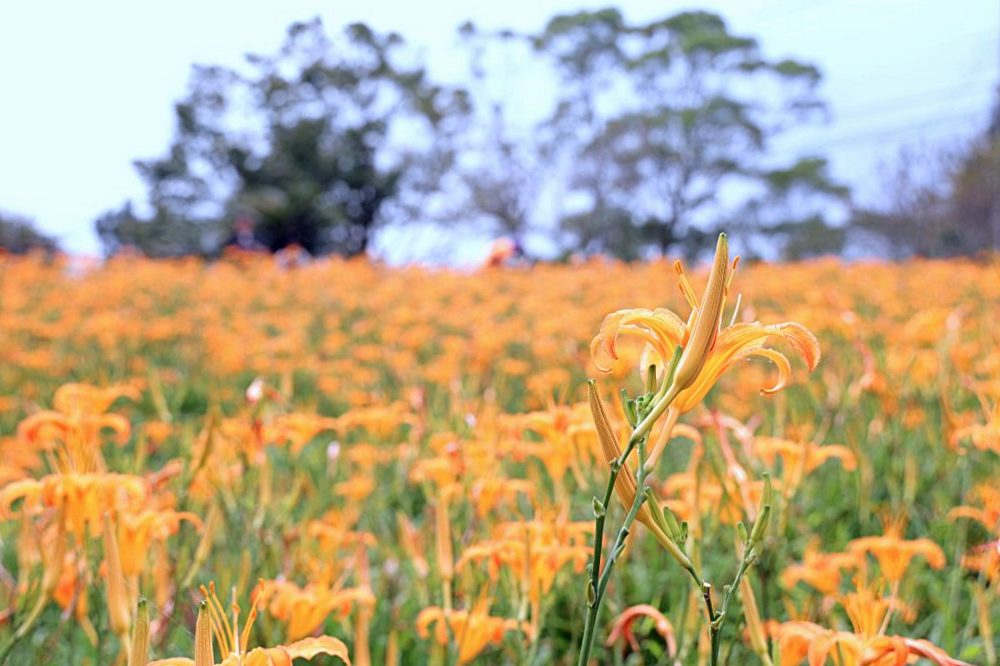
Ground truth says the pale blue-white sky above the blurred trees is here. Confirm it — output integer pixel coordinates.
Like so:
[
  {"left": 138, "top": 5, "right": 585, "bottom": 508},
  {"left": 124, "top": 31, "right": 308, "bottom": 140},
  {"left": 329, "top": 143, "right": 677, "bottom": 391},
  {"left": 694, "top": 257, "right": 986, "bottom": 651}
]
[{"left": 0, "top": 0, "right": 1000, "bottom": 254}]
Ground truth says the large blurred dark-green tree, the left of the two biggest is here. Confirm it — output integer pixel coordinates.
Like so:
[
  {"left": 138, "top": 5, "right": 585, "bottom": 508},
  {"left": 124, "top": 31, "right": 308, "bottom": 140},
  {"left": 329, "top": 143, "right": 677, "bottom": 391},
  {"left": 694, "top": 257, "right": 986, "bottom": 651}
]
[{"left": 98, "top": 19, "right": 468, "bottom": 255}]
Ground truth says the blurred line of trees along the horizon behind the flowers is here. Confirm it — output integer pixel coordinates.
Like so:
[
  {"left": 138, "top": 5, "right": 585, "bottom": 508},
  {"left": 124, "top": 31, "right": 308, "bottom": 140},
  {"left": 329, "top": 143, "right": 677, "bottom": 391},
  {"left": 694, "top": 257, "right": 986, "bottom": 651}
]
[{"left": 0, "top": 9, "right": 1000, "bottom": 260}]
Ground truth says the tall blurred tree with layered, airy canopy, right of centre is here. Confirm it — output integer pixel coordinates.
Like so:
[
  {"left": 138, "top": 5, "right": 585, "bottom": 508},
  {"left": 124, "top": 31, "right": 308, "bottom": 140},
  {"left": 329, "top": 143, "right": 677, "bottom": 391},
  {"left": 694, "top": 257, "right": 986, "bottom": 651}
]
[{"left": 531, "top": 9, "right": 845, "bottom": 257}]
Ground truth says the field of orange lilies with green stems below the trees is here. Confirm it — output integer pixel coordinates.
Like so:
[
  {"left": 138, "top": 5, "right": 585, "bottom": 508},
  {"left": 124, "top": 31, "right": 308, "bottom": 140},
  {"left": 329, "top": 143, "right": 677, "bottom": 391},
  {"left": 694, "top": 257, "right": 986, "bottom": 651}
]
[{"left": 0, "top": 255, "right": 1000, "bottom": 666}]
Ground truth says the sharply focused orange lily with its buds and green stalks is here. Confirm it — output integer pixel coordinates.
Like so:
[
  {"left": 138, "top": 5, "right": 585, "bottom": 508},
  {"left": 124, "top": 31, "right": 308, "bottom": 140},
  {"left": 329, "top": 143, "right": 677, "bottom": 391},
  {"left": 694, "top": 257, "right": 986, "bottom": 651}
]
[{"left": 577, "top": 234, "right": 796, "bottom": 666}]
